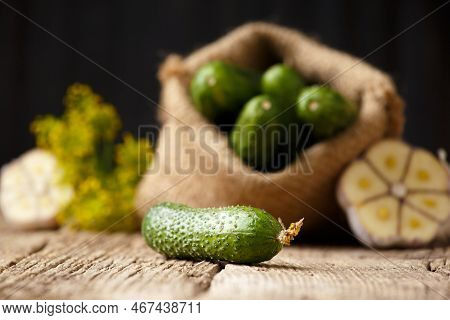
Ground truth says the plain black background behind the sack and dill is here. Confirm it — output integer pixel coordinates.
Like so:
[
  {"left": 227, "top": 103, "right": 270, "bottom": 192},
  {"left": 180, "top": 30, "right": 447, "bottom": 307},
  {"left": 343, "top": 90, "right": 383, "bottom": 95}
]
[{"left": 0, "top": 0, "right": 450, "bottom": 164}]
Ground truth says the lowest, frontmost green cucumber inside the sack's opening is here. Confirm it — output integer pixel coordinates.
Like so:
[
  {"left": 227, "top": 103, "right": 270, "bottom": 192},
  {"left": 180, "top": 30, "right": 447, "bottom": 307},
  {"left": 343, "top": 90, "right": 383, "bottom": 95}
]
[{"left": 230, "top": 95, "right": 290, "bottom": 171}]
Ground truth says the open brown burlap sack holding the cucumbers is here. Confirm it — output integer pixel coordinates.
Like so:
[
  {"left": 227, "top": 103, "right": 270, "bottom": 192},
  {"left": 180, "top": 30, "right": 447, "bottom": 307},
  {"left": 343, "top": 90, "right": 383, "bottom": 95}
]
[{"left": 136, "top": 22, "right": 403, "bottom": 231}]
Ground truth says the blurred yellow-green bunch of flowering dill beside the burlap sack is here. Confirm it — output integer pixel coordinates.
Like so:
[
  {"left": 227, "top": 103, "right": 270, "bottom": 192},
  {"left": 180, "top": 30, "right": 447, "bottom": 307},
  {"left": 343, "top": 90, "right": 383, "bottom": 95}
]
[{"left": 31, "top": 84, "right": 153, "bottom": 231}]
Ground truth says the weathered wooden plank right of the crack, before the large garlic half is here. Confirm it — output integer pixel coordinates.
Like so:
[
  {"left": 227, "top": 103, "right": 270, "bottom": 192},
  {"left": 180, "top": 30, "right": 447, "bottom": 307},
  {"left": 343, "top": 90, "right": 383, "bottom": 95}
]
[{"left": 202, "top": 247, "right": 450, "bottom": 299}]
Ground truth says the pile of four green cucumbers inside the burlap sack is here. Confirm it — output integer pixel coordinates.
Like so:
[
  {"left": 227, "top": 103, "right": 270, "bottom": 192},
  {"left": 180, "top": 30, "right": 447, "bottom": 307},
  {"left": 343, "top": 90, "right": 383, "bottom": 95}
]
[{"left": 190, "top": 61, "right": 358, "bottom": 171}]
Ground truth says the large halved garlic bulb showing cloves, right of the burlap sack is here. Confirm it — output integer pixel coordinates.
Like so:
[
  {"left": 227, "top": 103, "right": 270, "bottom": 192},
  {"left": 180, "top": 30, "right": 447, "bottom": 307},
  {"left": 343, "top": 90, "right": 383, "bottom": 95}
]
[{"left": 337, "top": 139, "right": 450, "bottom": 247}]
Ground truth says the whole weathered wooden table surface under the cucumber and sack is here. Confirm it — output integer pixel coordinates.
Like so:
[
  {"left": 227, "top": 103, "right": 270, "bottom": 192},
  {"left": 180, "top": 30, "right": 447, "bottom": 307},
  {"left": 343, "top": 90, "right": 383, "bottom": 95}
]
[{"left": 0, "top": 224, "right": 450, "bottom": 299}]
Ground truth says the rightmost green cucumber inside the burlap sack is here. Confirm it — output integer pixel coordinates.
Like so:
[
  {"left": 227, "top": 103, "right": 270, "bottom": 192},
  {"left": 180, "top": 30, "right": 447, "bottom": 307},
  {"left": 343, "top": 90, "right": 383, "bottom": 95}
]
[{"left": 297, "top": 86, "right": 358, "bottom": 139}]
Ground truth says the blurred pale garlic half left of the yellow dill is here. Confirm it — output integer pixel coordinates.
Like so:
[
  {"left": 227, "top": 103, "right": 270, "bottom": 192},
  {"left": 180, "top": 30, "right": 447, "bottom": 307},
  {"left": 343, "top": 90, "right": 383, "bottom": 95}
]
[{"left": 0, "top": 149, "right": 73, "bottom": 229}]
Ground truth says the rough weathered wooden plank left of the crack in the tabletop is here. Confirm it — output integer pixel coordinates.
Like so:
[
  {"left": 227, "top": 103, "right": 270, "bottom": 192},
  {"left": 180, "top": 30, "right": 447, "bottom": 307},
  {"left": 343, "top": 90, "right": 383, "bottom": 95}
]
[{"left": 0, "top": 231, "right": 220, "bottom": 299}]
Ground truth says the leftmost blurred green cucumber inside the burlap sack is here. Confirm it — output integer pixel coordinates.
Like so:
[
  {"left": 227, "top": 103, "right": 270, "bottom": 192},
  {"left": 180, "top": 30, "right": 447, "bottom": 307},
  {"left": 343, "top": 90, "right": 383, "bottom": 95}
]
[{"left": 190, "top": 61, "right": 261, "bottom": 120}]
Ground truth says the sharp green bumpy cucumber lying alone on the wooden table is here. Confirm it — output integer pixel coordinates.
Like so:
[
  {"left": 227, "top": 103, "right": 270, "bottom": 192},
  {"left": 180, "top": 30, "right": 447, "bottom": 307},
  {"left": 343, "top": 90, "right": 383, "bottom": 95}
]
[{"left": 142, "top": 203, "right": 282, "bottom": 264}]
